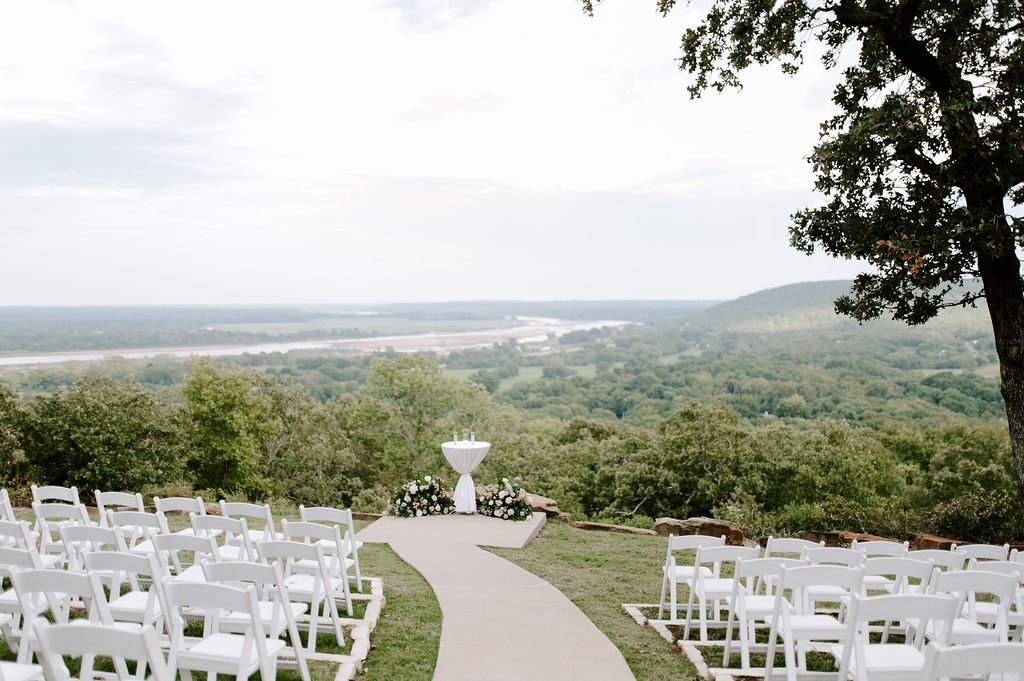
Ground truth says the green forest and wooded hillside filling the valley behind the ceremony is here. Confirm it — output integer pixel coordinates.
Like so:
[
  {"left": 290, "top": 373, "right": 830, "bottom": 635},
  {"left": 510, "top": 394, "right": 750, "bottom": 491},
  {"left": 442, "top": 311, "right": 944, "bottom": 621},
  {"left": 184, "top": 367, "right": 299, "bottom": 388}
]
[{"left": 0, "top": 282, "right": 1024, "bottom": 541}]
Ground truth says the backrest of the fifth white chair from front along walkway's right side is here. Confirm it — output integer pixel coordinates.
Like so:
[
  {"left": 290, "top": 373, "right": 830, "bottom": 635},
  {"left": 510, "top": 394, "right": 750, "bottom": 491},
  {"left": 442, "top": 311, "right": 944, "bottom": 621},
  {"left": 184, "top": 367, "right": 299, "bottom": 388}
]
[{"left": 839, "top": 594, "right": 959, "bottom": 679}]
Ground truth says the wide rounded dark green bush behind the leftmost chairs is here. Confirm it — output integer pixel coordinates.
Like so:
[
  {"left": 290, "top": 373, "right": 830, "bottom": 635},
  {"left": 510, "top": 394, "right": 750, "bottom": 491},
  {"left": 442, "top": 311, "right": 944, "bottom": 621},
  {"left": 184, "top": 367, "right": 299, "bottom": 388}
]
[{"left": 23, "top": 377, "right": 182, "bottom": 494}]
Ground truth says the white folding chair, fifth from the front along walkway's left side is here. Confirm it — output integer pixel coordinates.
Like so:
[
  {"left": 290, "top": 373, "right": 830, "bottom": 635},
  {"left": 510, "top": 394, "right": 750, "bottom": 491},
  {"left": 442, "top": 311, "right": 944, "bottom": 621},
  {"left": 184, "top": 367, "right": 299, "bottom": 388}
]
[{"left": 167, "top": 582, "right": 285, "bottom": 681}]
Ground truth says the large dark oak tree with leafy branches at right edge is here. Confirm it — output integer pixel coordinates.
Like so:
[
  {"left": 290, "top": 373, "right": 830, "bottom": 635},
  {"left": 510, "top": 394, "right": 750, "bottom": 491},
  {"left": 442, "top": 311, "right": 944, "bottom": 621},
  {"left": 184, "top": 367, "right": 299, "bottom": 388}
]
[{"left": 585, "top": 0, "right": 1024, "bottom": 497}]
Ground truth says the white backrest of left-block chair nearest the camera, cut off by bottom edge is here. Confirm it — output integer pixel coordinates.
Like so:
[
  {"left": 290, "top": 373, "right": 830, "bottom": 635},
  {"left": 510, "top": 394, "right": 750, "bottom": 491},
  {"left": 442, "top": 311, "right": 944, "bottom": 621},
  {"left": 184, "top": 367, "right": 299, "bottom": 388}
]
[{"left": 35, "top": 622, "right": 174, "bottom": 681}]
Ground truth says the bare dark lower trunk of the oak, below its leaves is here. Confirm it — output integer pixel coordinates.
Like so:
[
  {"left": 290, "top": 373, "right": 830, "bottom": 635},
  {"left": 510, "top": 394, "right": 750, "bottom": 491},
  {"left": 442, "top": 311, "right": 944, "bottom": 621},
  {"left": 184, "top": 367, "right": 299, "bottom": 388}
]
[{"left": 978, "top": 249, "right": 1024, "bottom": 500}]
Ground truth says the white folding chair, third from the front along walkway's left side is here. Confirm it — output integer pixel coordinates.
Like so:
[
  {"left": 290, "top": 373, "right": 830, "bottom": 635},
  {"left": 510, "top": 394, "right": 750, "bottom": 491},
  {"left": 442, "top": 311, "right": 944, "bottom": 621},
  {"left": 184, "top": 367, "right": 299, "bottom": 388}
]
[{"left": 257, "top": 541, "right": 345, "bottom": 652}]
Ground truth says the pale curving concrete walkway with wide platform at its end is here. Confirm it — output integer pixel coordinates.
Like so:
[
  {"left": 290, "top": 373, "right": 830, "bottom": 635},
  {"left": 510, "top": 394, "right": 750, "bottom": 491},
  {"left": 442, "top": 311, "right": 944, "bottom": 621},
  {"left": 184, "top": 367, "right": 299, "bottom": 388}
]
[{"left": 358, "top": 515, "right": 634, "bottom": 681}]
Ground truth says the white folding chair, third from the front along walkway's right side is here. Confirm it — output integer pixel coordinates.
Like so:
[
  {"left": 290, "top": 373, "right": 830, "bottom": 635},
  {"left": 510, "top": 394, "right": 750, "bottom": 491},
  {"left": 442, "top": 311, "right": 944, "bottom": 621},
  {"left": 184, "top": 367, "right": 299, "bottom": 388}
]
[{"left": 722, "top": 558, "right": 807, "bottom": 670}]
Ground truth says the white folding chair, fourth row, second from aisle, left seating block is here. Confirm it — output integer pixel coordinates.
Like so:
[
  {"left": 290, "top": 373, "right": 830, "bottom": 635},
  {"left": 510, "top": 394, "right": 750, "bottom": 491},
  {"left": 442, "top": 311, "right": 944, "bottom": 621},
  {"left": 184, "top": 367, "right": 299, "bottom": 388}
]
[{"left": 85, "top": 551, "right": 171, "bottom": 633}]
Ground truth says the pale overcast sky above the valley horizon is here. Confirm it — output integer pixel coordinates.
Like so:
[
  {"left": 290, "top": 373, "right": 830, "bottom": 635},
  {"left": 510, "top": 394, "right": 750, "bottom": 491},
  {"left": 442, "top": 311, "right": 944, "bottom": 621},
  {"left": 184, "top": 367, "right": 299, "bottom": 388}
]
[{"left": 0, "top": 0, "right": 859, "bottom": 304}]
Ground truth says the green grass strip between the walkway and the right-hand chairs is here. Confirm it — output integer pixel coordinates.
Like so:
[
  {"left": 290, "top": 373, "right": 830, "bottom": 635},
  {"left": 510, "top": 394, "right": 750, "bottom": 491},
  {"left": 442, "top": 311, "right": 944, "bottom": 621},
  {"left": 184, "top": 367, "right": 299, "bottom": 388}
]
[{"left": 490, "top": 522, "right": 697, "bottom": 681}]
